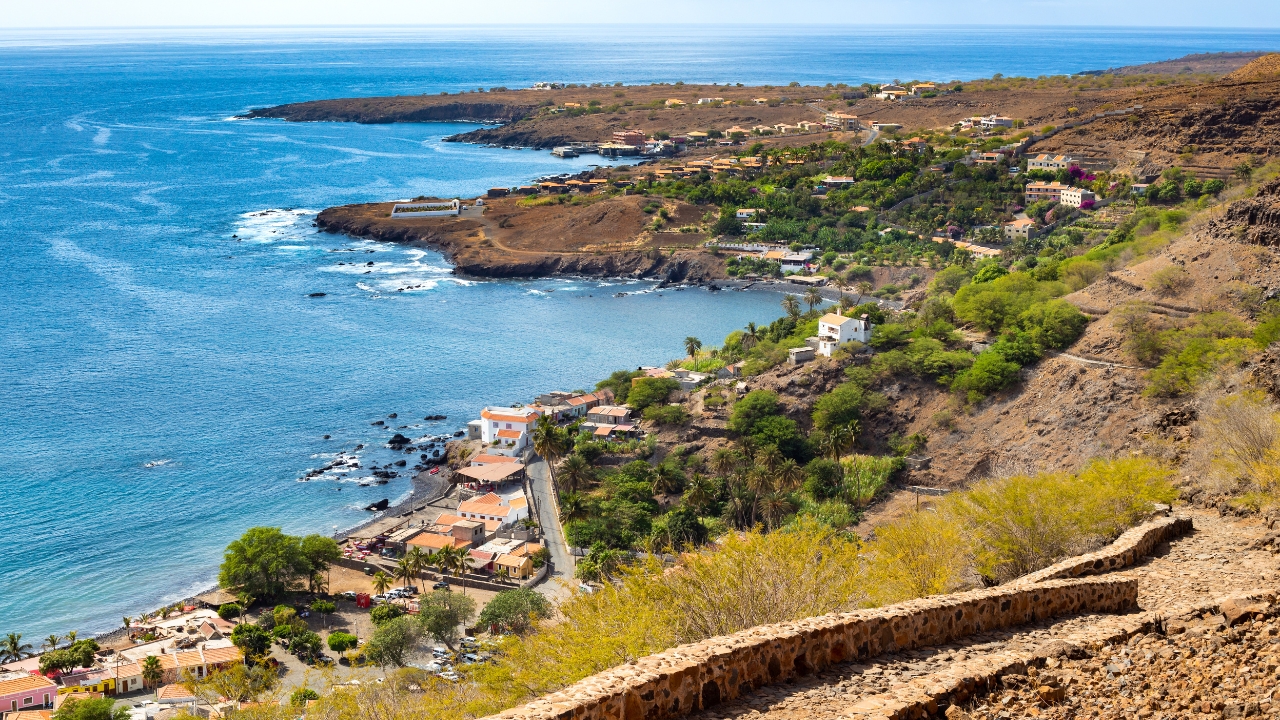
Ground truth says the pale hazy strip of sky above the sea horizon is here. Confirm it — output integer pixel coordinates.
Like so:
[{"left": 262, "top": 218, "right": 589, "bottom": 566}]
[{"left": 0, "top": 0, "right": 1280, "bottom": 29}]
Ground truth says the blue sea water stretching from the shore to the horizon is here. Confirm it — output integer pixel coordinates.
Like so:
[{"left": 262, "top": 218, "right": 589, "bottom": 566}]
[{"left": 0, "top": 28, "right": 1280, "bottom": 638}]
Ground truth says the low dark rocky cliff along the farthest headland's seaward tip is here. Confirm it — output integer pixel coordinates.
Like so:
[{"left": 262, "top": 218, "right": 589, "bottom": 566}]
[{"left": 243, "top": 96, "right": 535, "bottom": 124}]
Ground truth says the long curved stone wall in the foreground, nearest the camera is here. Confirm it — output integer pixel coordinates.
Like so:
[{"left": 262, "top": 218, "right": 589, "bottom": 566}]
[{"left": 483, "top": 578, "right": 1138, "bottom": 720}]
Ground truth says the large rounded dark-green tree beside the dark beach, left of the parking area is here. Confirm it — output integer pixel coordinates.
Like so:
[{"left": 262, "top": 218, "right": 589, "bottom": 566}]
[{"left": 218, "top": 528, "right": 311, "bottom": 598}]
